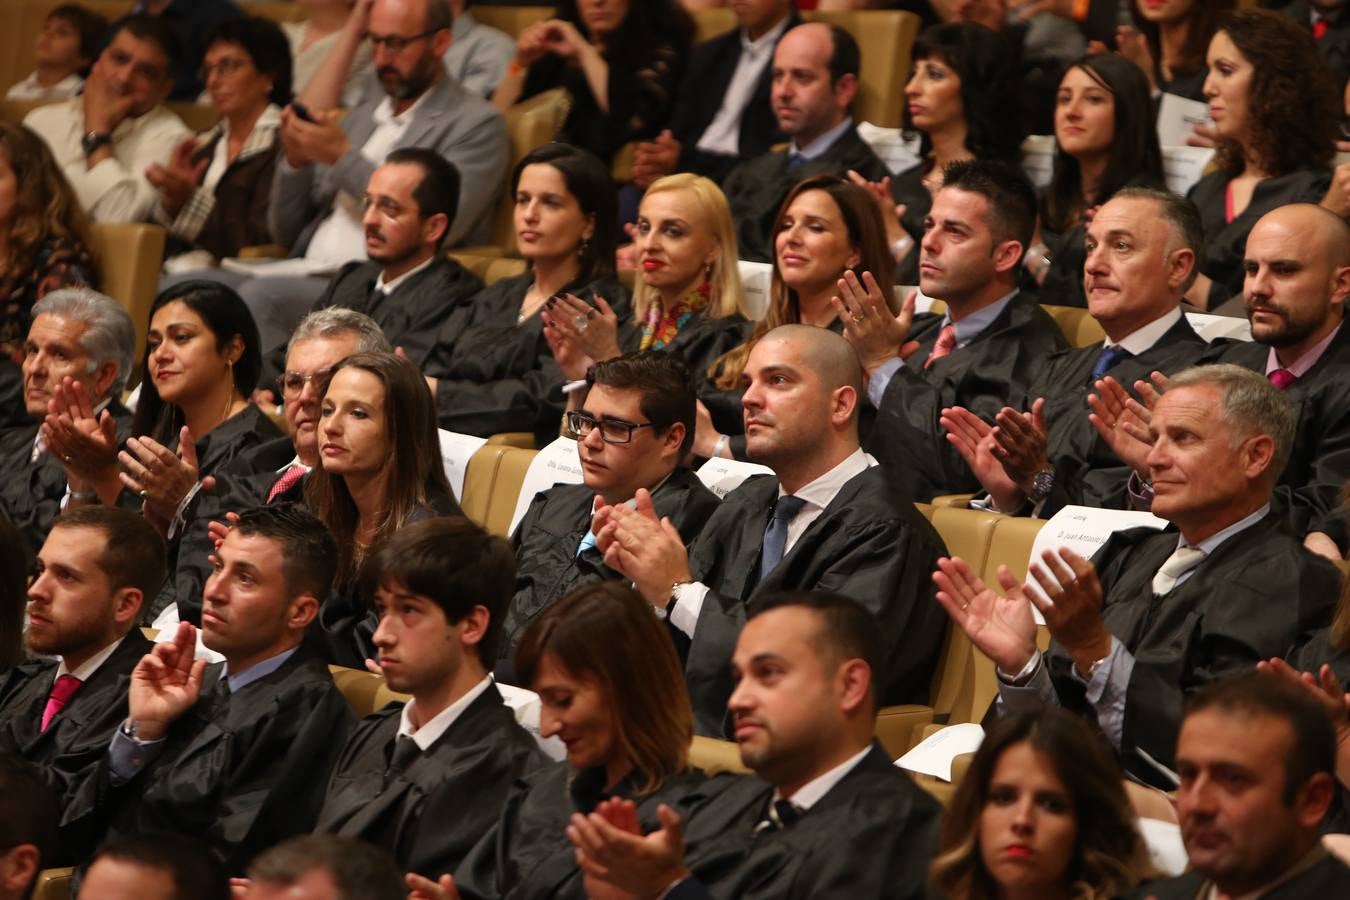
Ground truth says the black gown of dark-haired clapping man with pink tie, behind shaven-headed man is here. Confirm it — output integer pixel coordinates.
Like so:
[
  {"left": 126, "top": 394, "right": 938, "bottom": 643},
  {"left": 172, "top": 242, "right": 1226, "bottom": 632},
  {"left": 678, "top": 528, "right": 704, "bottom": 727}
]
[{"left": 863, "top": 299, "right": 1068, "bottom": 503}]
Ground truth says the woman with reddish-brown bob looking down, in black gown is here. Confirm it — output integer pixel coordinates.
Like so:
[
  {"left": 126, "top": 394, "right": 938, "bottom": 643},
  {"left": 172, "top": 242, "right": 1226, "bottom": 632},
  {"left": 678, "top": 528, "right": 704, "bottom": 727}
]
[{"left": 429, "top": 582, "right": 703, "bottom": 900}]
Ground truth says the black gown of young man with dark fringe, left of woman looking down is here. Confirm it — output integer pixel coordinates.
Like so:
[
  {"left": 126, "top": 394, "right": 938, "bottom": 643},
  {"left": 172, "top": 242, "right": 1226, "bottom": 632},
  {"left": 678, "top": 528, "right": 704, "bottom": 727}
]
[{"left": 315, "top": 684, "right": 548, "bottom": 880}]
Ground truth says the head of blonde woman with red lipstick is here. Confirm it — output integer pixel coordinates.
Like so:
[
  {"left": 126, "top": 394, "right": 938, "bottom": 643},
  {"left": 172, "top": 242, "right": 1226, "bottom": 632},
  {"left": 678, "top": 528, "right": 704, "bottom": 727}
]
[{"left": 633, "top": 173, "right": 749, "bottom": 330}]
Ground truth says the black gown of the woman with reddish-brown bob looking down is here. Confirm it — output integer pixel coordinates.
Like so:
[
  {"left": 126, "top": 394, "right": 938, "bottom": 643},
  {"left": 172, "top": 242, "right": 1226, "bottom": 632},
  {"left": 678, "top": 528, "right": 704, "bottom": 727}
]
[{"left": 455, "top": 762, "right": 703, "bottom": 900}]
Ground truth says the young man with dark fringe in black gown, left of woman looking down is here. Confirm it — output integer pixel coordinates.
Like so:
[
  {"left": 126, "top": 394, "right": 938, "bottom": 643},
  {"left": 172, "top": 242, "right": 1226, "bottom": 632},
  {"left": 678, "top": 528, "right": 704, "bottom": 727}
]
[{"left": 316, "top": 517, "right": 545, "bottom": 878}]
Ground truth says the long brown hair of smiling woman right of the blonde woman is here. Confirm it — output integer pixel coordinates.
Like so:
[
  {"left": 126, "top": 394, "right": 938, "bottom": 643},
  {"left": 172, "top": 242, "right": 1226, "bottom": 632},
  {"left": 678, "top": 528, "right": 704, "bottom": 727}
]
[{"left": 707, "top": 175, "right": 899, "bottom": 390}]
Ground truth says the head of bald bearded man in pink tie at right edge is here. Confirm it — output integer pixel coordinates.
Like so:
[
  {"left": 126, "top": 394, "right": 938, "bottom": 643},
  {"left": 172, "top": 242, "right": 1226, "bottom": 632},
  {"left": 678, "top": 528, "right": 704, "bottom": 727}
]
[{"left": 1242, "top": 204, "right": 1350, "bottom": 366}]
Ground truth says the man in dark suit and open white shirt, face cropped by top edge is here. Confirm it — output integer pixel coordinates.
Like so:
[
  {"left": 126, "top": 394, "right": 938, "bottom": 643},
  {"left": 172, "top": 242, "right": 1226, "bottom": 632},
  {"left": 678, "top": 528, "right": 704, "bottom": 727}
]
[{"left": 633, "top": 0, "right": 801, "bottom": 188}]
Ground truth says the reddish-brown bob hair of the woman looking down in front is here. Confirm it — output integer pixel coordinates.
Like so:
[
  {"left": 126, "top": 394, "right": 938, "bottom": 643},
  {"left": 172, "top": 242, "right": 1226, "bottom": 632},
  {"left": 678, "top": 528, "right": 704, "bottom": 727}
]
[{"left": 516, "top": 582, "right": 694, "bottom": 795}]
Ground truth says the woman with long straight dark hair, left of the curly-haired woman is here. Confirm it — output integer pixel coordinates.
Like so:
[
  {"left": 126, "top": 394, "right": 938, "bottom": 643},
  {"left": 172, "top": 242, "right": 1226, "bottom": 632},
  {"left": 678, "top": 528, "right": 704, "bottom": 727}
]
[{"left": 1026, "top": 54, "right": 1165, "bottom": 306}]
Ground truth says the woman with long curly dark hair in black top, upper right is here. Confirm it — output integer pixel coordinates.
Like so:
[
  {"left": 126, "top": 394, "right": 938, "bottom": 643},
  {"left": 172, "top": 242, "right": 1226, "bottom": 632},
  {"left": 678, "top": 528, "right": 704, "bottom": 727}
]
[{"left": 1187, "top": 9, "right": 1341, "bottom": 314}]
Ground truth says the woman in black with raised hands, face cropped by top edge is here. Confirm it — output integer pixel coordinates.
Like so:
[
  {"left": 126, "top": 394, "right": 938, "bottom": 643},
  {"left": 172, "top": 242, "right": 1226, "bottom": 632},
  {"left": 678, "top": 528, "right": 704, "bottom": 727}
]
[{"left": 493, "top": 0, "right": 694, "bottom": 161}]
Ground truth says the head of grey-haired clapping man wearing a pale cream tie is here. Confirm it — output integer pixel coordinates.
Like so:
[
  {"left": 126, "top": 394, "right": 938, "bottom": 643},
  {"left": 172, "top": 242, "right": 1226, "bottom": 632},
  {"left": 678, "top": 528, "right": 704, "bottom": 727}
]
[{"left": 1148, "top": 364, "right": 1295, "bottom": 545}]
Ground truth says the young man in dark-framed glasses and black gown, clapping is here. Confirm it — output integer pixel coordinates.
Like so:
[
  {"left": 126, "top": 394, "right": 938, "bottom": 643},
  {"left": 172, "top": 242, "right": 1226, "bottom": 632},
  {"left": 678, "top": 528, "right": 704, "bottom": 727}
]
[{"left": 497, "top": 351, "right": 717, "bottom": 679}]
